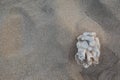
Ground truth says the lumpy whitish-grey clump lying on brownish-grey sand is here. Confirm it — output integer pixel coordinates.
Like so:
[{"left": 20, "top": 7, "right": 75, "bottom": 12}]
[{"left": 75, "top": 32, "right": 100, "bottom": 68}]
